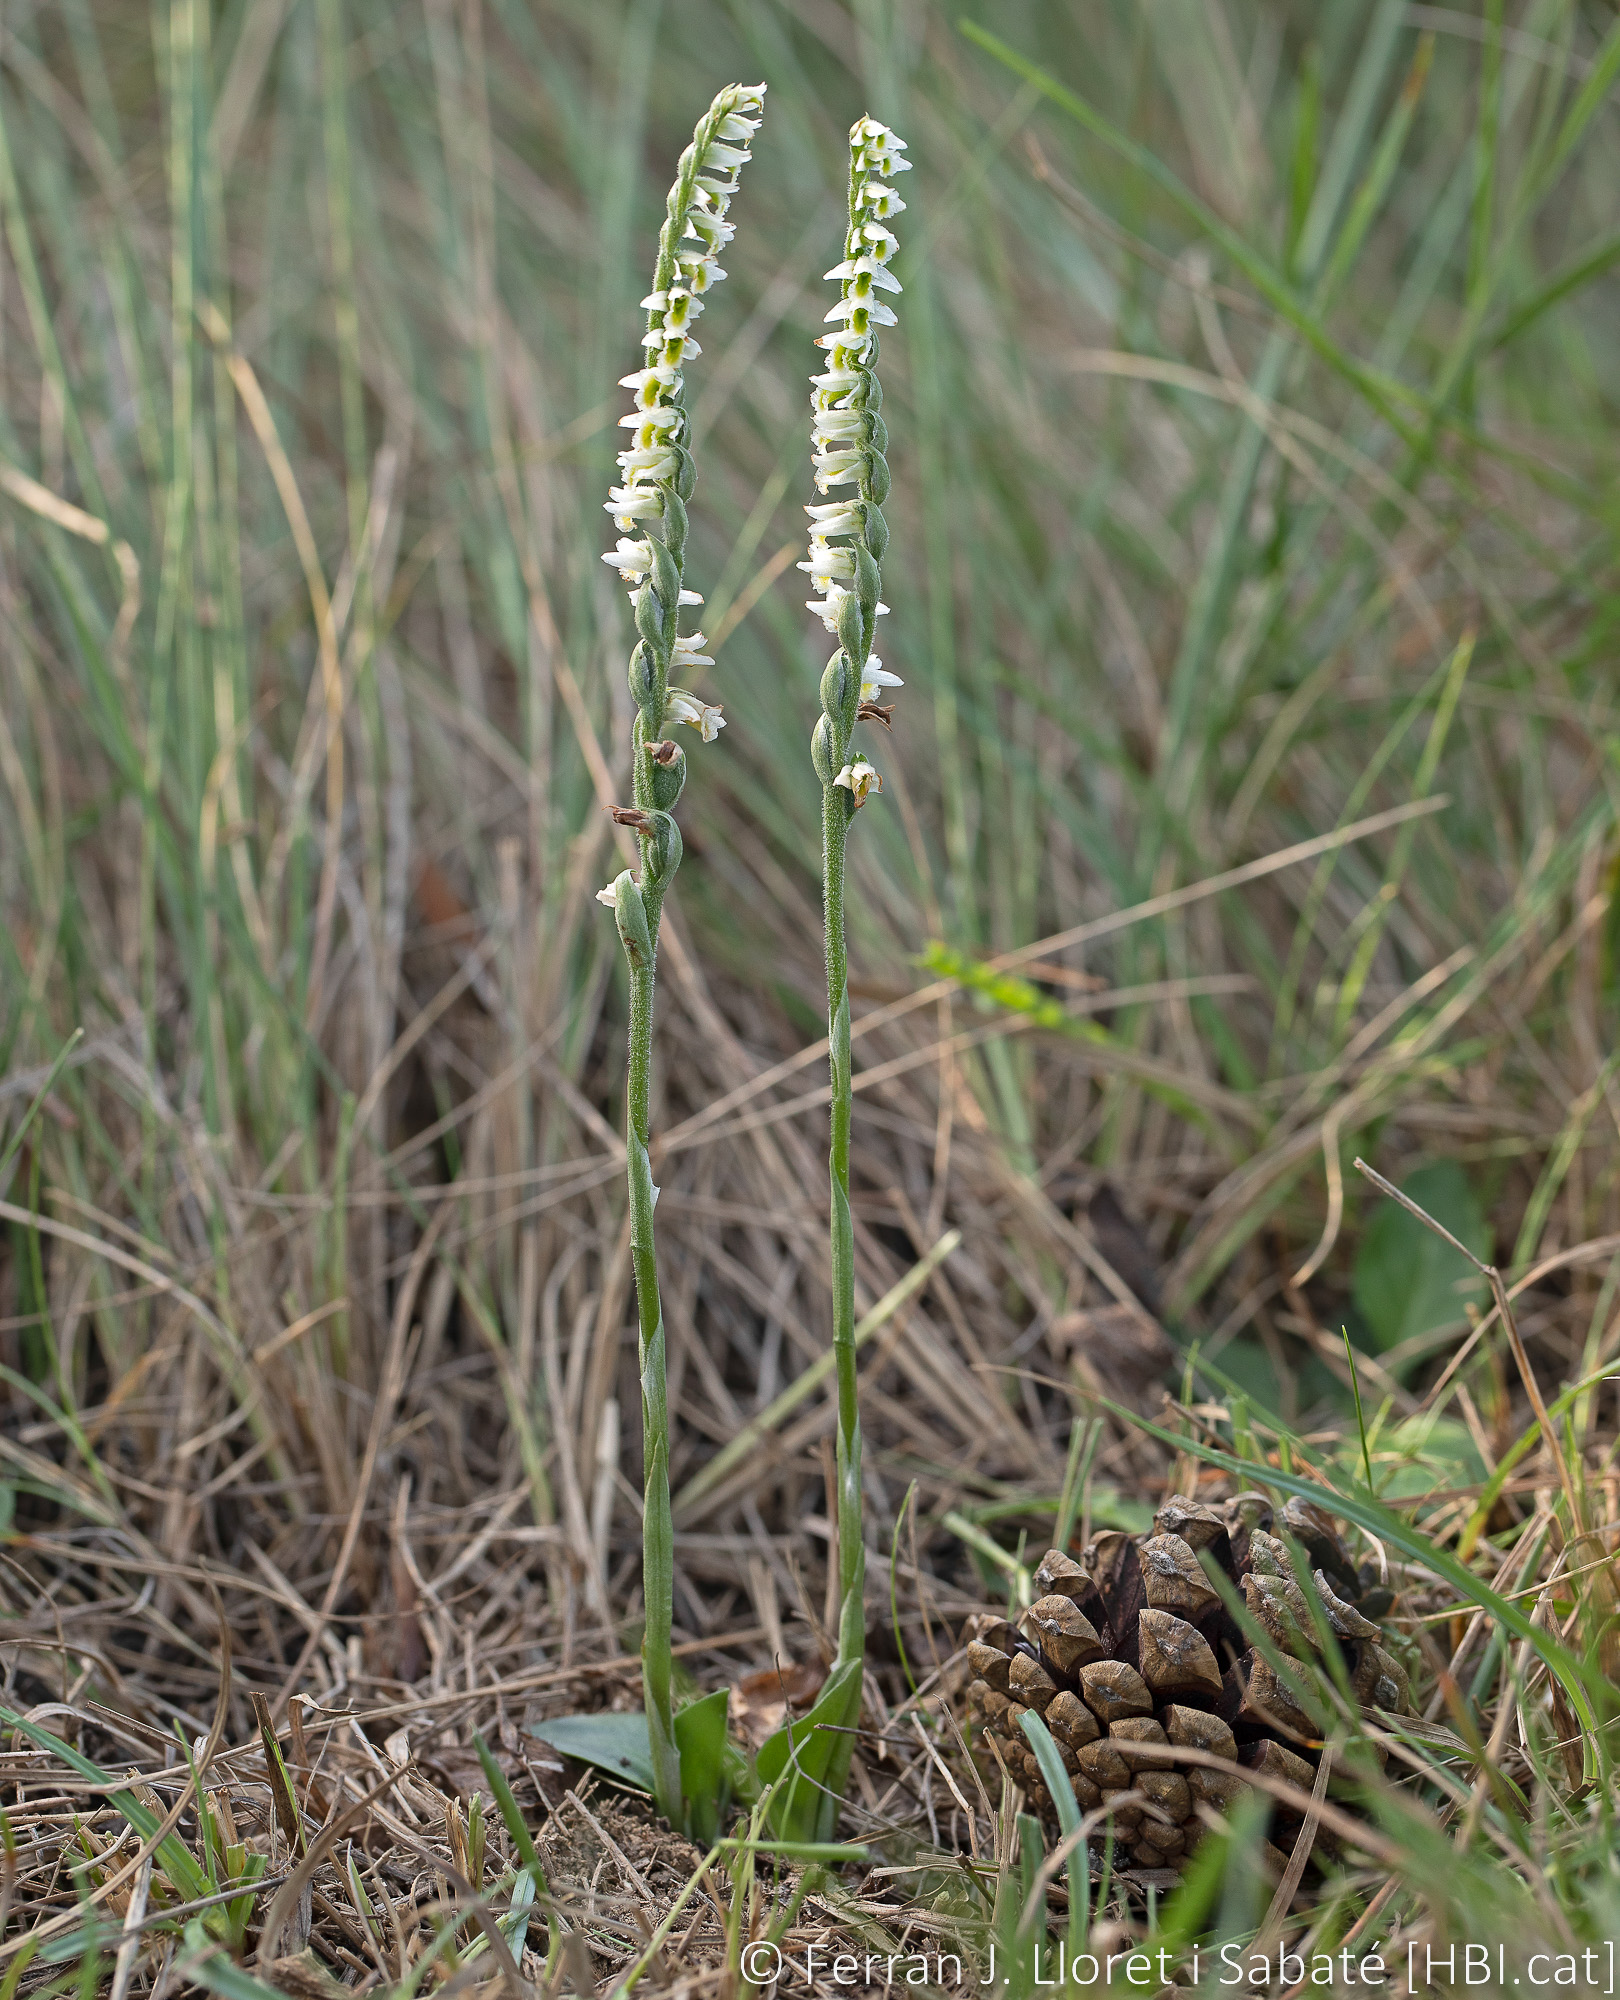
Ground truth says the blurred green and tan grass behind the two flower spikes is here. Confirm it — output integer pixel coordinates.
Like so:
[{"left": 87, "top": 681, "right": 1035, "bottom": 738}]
[{"left": 0, "top": 0, "right": 1620, "bottom": 1708}]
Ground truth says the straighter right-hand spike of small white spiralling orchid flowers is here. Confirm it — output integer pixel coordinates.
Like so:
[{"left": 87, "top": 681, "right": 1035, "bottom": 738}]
[{"left": 800, "top": 118, "right": 910, "bottom": 812}]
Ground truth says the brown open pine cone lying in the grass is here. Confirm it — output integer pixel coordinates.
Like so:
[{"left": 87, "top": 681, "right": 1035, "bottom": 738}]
[{"left": 968, "top": 1492, "right": 1412, "bottom": 1872}]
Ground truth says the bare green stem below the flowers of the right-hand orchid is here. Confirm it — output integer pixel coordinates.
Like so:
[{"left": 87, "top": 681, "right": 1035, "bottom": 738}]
[{"left": 822, "top": 784, "right": 866, "bottom": 1672}]
